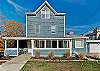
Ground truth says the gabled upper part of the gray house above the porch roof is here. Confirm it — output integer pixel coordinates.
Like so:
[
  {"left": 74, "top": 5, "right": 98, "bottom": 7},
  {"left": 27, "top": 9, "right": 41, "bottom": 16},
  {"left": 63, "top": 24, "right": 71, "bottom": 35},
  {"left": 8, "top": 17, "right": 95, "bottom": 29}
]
[{"left": 26, "top": 1, "right": 65, "bottom": 38}]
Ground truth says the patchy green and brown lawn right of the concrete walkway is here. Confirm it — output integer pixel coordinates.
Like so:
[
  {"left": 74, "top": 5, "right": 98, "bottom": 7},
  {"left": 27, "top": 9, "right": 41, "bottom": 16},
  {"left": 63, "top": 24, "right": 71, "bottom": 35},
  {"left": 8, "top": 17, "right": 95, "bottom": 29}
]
[{"left": 21, "top": 61, "right": 100, "bottom": 71}]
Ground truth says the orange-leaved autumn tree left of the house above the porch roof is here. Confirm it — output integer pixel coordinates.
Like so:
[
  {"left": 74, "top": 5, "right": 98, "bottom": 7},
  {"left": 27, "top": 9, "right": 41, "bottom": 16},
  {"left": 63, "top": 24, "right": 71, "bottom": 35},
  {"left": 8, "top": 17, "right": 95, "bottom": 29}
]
[{"left": 2, "top": 21, "right": 23, "bottom": 37}]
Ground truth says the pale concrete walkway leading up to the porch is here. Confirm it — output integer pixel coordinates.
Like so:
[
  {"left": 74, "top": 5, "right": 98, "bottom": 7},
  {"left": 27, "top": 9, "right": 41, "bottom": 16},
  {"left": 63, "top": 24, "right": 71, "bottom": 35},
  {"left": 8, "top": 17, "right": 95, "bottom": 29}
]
[{"left": 0, "top": 54, "right": 31, "bottom": 71}]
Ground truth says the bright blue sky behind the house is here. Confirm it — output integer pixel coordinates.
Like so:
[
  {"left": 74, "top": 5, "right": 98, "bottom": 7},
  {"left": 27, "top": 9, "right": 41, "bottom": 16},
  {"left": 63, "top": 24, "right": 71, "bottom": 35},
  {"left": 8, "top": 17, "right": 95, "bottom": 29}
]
[{"left": 0, "top": 0, "right": 100, "bottom": 34}]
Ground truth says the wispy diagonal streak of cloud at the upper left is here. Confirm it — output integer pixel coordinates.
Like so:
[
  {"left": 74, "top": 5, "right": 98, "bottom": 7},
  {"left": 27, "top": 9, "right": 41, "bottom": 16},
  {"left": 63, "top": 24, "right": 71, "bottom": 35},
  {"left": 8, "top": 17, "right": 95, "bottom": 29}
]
[{"left": 7, "top": 0, "right": 26, "bottom": 16}]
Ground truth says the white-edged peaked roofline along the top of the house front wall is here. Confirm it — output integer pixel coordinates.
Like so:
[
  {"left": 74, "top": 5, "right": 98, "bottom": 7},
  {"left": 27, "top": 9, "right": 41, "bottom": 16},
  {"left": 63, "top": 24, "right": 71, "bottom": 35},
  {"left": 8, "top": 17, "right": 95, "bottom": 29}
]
[{"left": 26, "top": 1, "right": 66, "bottom": 15}]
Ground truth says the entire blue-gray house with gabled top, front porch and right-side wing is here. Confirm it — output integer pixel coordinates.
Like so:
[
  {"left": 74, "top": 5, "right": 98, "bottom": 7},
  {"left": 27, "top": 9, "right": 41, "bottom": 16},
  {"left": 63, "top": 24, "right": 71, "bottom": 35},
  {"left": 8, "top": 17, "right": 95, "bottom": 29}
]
[{"left": 2, "top": 1, "right": 99, "bottom": 56}]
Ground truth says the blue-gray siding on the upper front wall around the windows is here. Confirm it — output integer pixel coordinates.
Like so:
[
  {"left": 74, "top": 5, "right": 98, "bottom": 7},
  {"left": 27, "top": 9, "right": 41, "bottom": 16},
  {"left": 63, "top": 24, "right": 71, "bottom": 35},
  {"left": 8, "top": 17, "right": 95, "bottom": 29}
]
[{"left": 27, "top": 7, "right": 64, "bottom": 37}]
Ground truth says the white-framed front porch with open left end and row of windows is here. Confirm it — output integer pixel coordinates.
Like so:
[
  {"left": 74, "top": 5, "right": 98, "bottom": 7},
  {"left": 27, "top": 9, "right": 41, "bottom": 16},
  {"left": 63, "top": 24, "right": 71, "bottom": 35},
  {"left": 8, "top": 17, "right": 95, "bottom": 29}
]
[{"left": 2, "top": 37, "right": 72, "bottom": 56}]
